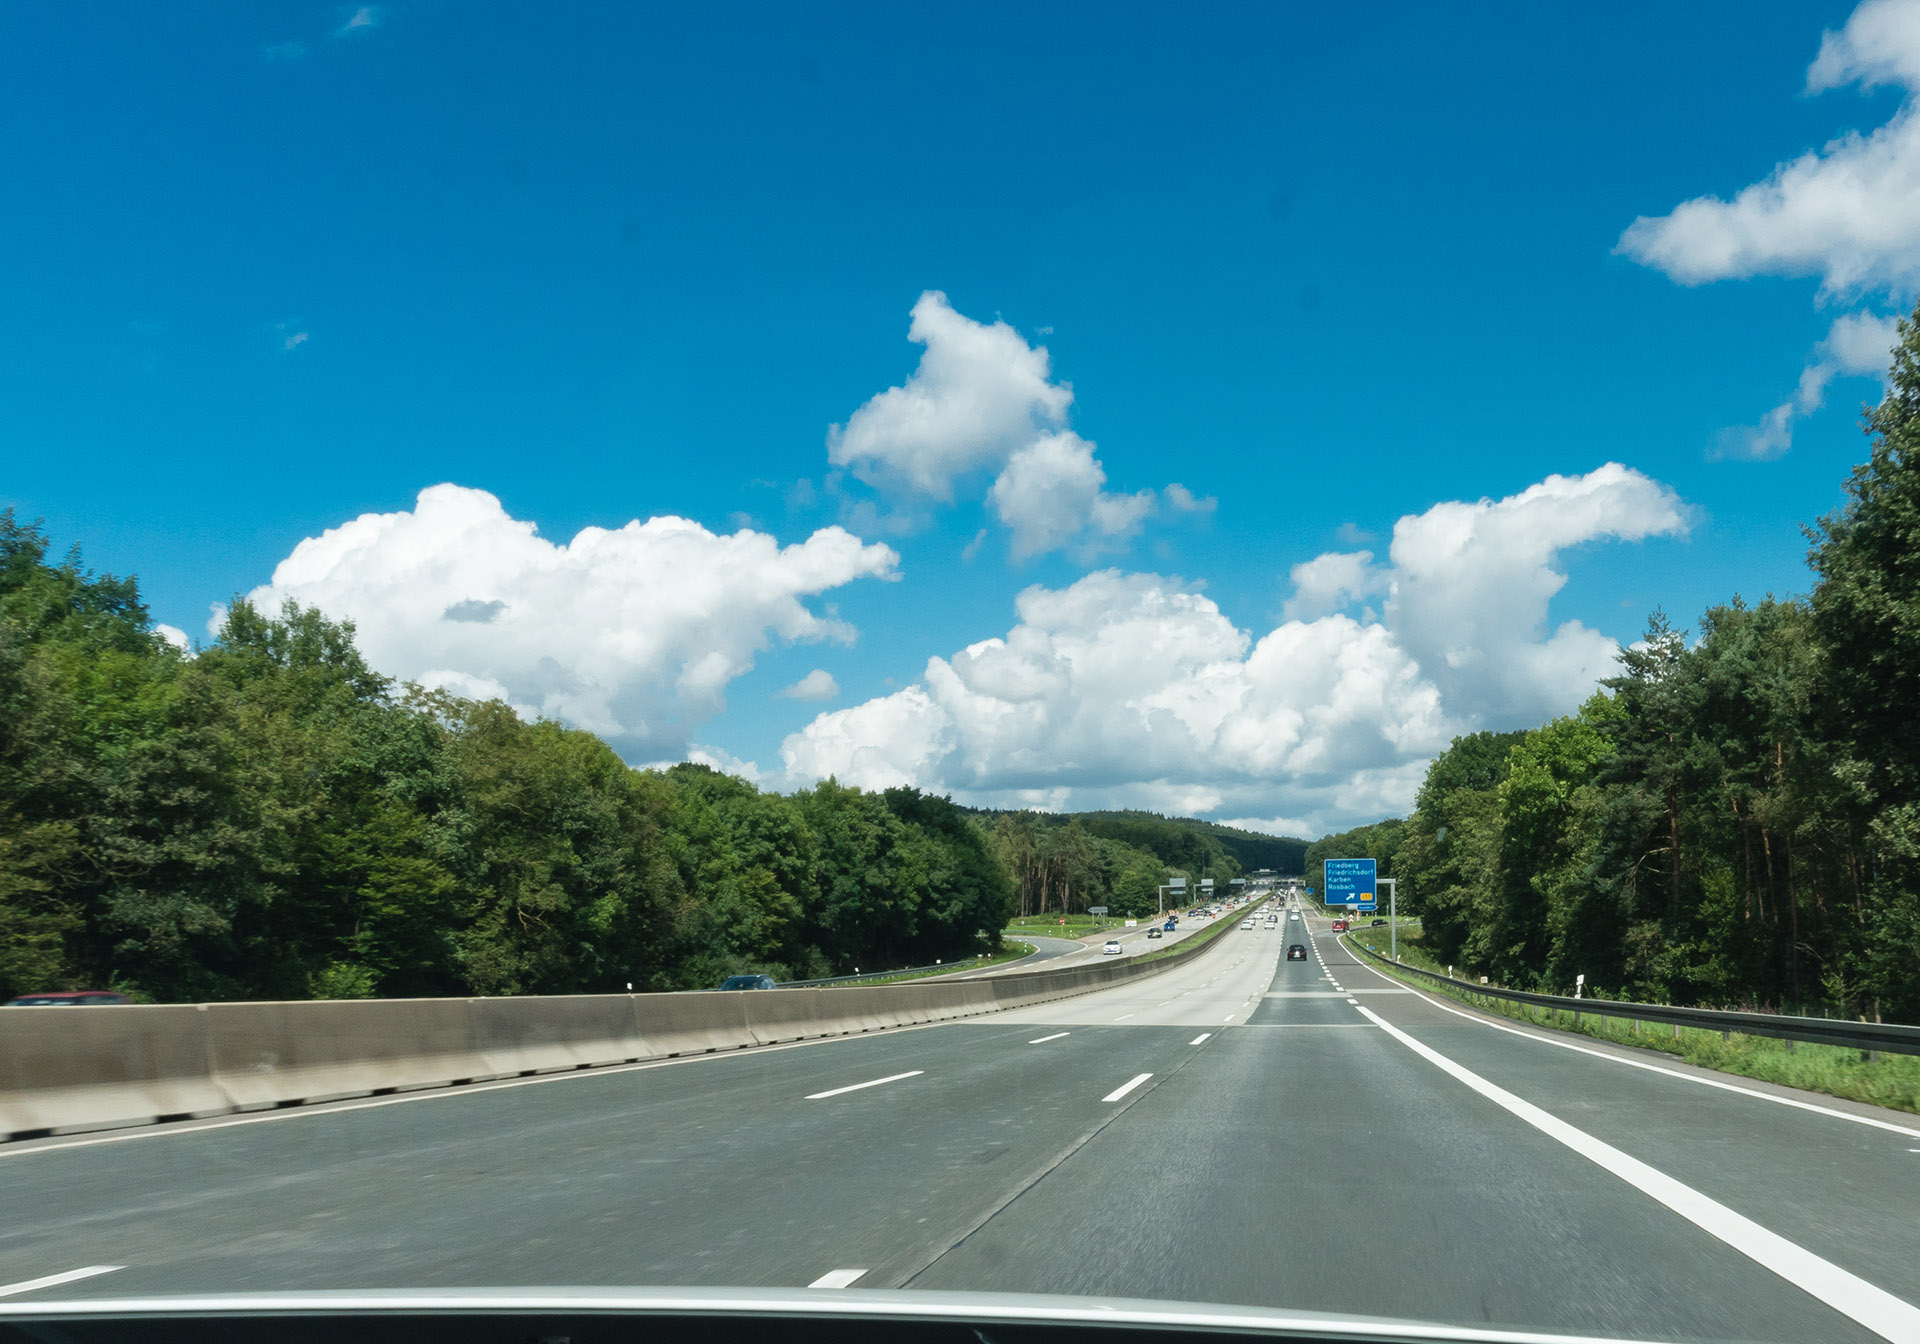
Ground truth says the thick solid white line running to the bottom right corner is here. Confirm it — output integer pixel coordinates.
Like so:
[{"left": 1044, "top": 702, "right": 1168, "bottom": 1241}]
[{"left": 1359, "top": 1008, "right": 1920, "bottom": 1344}]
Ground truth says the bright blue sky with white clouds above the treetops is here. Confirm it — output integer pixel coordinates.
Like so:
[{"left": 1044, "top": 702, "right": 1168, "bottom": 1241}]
[{"left": 0, "top": 0, "right": 1920, "bottom": 829}]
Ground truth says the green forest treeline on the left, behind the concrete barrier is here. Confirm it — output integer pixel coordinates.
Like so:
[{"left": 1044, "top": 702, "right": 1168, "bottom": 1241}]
[{"left": 0, "top": 526, "right": 1297, "bottom": 1002}]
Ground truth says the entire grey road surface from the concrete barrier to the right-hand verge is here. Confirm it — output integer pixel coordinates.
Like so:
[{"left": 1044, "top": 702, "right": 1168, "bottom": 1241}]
[{"left": 0, "top": 890, "right": 1920, "bottom": 1340}]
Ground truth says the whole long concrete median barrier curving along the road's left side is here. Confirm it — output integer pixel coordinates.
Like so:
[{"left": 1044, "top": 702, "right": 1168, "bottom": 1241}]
[{"left": 0, "top": 910, "right": 1259, "bottom": 1139}]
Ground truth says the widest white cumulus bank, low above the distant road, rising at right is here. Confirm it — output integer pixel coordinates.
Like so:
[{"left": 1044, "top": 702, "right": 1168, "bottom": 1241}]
[{"left": 781, "top": 465, "right": 1686, "bottom": 831}]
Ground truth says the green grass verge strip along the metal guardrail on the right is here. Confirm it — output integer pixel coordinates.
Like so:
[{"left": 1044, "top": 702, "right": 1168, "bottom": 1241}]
[{"left": 1352, "top": 929, "right": 1920, "bottom": 1114}]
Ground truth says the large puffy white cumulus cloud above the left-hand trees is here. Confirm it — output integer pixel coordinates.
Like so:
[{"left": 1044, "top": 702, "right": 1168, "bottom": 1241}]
[{"left": 232, "top": 484, "right": 899, "bottom": 758}]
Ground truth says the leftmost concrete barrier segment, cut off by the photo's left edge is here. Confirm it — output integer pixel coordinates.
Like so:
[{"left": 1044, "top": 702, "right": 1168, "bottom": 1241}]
[{"left": 0, "top": 1004, "right": 232, "bottom": 1137}]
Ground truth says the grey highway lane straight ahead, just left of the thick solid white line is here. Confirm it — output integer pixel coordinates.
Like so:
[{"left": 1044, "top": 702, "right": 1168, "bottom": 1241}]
[{"left": 912, "top": 925, "right": 1872, "bottom": 1340}]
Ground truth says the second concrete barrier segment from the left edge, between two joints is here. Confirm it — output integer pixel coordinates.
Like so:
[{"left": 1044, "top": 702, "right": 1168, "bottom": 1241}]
[{"left": 204, "top": 998, "right": 499, "bottom": 1110}]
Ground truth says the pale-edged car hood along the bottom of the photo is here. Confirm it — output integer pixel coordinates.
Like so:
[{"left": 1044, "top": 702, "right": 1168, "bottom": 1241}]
[{"left": 0, "top": 1288, "right": 1674, "bottom": 1344}]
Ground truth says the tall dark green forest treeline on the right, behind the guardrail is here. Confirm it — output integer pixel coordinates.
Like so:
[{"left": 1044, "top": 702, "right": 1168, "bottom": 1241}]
[{"left": 1308, "top": 313, "right": 1920, "bottom": 1021}]
